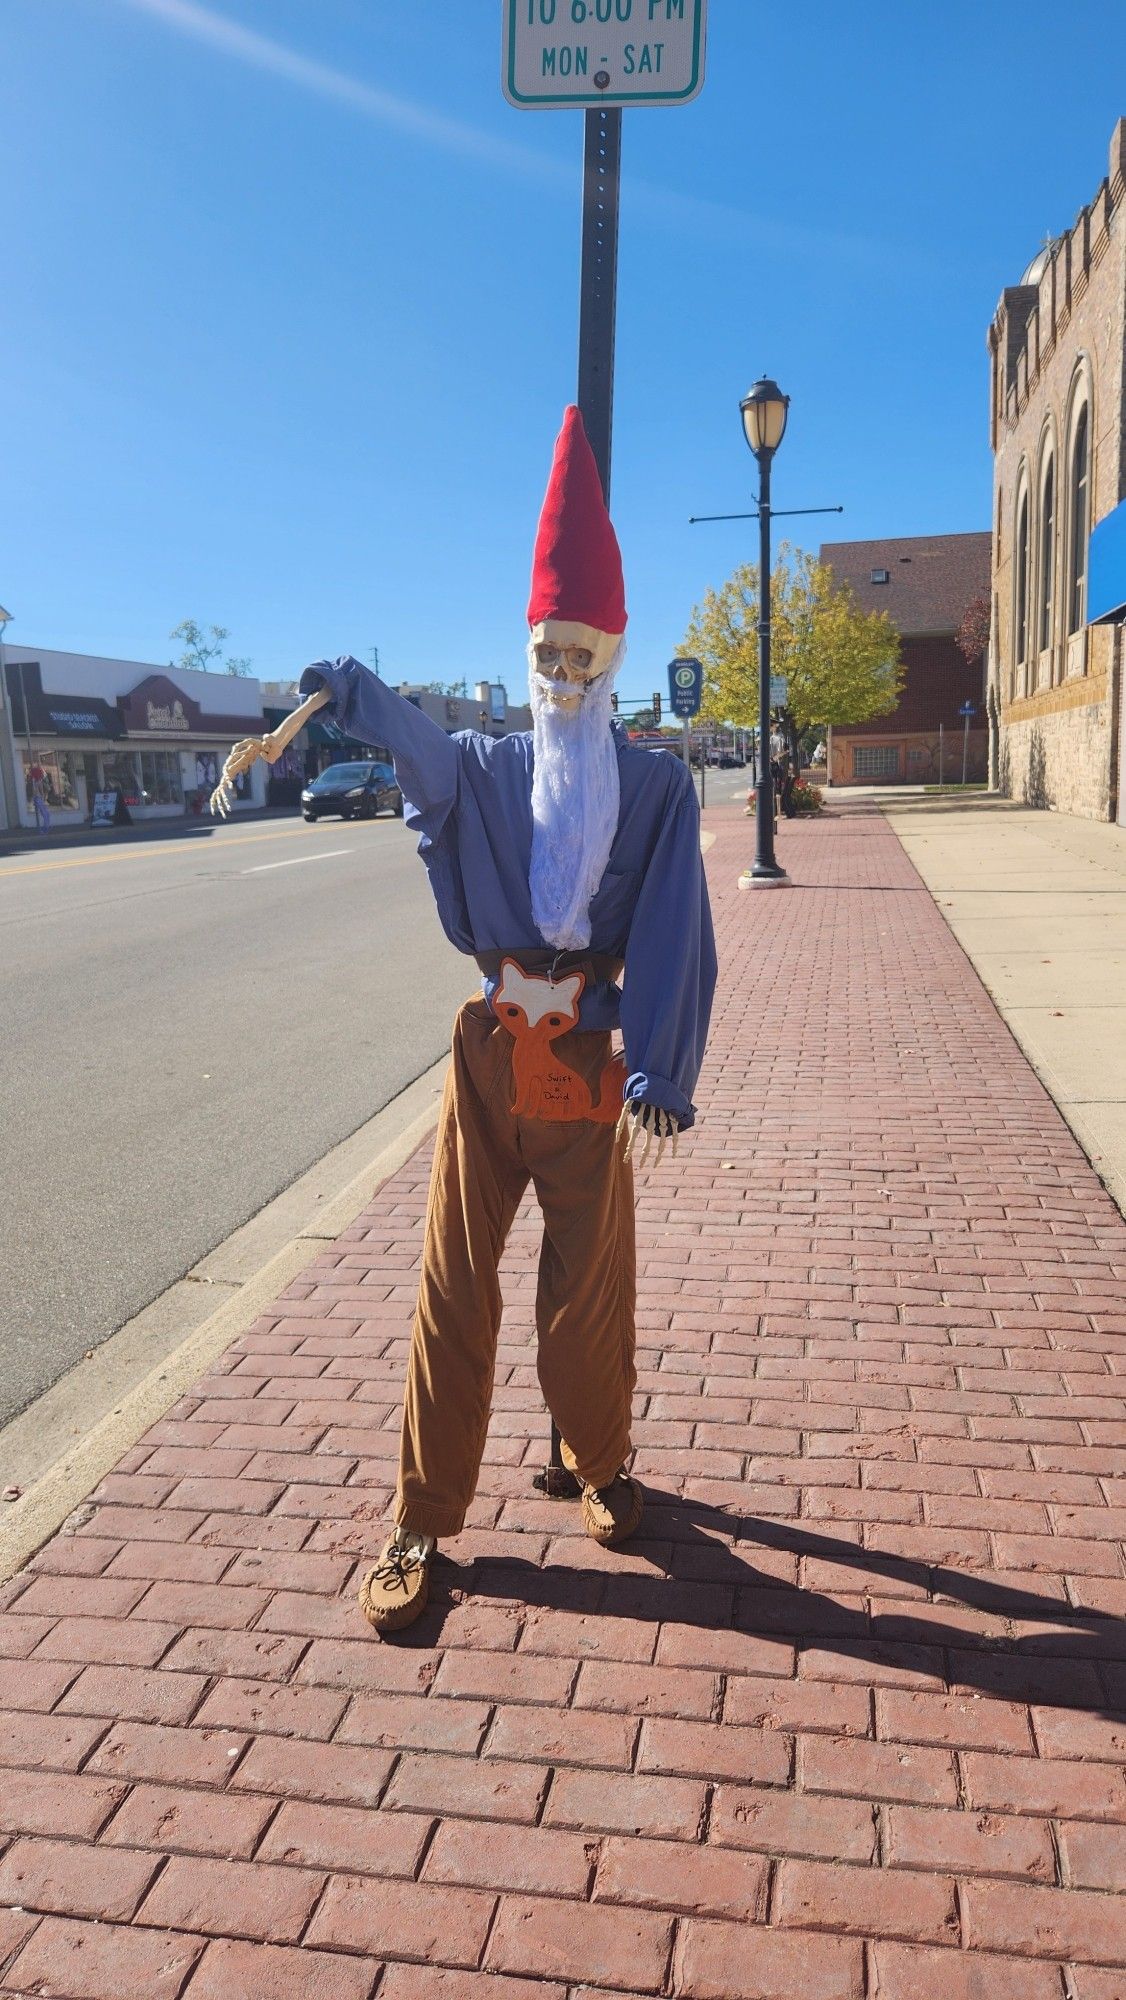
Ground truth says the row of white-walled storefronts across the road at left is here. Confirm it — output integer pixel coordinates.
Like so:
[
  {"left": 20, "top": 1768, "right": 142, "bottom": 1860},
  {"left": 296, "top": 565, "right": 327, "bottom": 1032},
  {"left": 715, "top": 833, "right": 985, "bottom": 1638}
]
[{"left": 4, "top": 646, "right": 266, "bottom": 826}]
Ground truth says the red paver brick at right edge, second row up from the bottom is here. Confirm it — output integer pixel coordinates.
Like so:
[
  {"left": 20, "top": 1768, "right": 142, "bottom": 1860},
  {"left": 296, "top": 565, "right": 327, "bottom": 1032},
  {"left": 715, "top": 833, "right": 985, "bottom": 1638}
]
[{"left": 962, "top": 1880, "right": 1126, "bottom": 1968}]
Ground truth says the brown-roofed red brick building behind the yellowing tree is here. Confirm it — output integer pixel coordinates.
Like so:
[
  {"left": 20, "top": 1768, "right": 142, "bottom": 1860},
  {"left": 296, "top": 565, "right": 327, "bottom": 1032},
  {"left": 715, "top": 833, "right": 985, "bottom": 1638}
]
[{"left": 820, "top": 532, "right": 990, "bottom": 784}]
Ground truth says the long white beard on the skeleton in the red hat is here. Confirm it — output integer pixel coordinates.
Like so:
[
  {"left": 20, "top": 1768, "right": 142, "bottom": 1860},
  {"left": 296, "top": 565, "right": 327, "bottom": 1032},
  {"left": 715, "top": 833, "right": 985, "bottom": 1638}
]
[{"left": 528, "top": 640, "right": 626, "bottom": 952}]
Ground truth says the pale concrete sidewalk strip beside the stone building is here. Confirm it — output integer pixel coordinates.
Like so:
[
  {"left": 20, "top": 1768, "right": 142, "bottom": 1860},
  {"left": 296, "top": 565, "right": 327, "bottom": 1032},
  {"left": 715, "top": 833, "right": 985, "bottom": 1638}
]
[{"left": 884, "top": 794, "right": 1126, "bottom": 1210}]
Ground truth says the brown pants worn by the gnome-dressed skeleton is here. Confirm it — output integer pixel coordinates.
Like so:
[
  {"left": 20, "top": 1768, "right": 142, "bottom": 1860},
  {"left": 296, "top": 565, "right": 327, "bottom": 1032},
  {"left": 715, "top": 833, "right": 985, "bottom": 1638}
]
[{"left": 394, "top": 998, "right": 636, "bottom": 1536}]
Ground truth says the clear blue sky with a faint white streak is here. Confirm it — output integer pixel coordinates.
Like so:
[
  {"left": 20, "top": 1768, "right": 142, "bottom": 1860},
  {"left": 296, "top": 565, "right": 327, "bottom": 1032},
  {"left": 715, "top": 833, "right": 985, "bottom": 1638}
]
[{"left": 0, "top": 0, "right": 1126, "bottom": 698}]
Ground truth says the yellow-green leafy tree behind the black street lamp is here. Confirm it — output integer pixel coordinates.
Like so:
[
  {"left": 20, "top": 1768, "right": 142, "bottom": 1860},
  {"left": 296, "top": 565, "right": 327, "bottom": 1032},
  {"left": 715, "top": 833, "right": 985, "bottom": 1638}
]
[{"left": 680, "top": 542, "right": 904, "bottom": 750}]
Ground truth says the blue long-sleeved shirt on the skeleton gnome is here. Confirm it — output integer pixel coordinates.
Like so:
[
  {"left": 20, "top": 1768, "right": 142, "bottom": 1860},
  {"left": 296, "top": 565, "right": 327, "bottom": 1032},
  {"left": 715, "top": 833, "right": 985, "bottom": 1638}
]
[{"left": 300, "top": 654, "right": 716, "bottom": 1128}]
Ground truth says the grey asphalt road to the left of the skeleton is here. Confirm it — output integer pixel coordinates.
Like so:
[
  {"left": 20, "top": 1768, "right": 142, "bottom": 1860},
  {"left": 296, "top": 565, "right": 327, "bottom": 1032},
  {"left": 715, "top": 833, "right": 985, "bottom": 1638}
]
[{"left": 0, "top": 818, "right": 476, "bottom": 1422}]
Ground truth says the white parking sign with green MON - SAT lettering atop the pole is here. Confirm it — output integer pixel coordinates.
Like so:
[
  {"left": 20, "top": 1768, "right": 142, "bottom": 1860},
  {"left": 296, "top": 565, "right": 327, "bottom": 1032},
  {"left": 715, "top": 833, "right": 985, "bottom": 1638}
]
[{"left": 502, "top": 0, "right": 708, "bottom": 110}]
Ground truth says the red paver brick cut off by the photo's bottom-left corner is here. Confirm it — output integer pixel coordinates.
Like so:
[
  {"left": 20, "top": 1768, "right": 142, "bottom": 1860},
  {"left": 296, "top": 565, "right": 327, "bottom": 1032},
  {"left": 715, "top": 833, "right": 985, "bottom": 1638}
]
[{"left": 8, "top": 1916, "right": 204, "bottom": 2000}]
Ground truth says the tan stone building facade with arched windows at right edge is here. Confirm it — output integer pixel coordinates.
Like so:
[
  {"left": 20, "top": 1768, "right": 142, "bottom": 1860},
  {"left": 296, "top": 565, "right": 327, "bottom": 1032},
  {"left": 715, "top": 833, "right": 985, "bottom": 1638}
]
[{"left": 988, "top": 118, "right": 1126, "bottom": 820}]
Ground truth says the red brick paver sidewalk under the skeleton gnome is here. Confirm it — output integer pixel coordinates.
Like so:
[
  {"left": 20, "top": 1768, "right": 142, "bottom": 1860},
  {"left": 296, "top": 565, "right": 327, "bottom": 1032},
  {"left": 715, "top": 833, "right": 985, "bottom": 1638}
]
[{"left": 0, "top": 808, "right": 1126, "bottom": 2000}]
